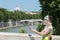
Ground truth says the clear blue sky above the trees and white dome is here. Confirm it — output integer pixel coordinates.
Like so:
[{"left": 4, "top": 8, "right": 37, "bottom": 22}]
[{"left": 0, "top": 0, "right": 41, "bottom": 11}]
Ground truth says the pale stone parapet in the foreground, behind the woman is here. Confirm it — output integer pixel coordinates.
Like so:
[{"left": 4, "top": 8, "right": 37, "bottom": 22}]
[{"left": 0, "top": 32, "right": 60, "bottom": 40}]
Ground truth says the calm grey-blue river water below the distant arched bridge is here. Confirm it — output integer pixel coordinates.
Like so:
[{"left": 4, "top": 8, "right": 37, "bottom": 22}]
[{"left": 0, "top": 25, "right": 38, "bottom": 34}]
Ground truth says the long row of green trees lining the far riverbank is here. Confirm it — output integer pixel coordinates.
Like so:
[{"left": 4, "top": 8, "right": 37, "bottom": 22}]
[{"left": 0, "top": 8, "right": 41, "bottom": 22}]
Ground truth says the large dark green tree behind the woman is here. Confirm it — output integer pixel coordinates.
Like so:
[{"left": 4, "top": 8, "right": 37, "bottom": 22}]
[{"left": 39, "top": 0, "right": 60, "bottom": 35}]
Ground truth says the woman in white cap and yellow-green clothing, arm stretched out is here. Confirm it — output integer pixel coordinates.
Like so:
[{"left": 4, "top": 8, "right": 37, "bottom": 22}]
[{"left": 30, "top": 15, "right": 53, "bottom": 40}]
